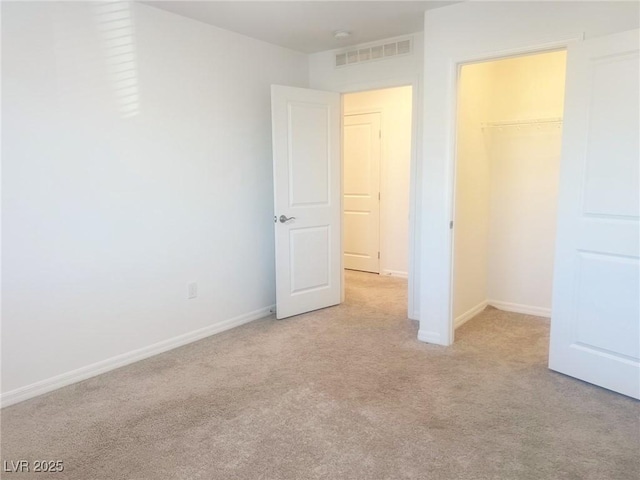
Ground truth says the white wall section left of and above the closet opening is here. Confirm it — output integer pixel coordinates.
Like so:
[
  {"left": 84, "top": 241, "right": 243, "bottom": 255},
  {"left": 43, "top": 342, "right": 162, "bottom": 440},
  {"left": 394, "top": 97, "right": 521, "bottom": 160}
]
[{"left": 418, "top": 2, "right": 640, "bottom": 345}]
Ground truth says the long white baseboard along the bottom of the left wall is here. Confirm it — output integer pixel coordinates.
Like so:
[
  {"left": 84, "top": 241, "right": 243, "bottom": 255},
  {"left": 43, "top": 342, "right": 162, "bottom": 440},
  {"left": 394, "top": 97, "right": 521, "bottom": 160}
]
[{"left": 0, "top": 305, "right": 275, "bottom": 408}]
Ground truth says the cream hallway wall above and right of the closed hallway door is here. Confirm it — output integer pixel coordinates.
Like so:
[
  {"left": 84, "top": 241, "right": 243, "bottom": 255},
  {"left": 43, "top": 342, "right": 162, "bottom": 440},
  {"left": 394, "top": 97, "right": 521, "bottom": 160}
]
[{"left": 343, "top": 86, "right": 412, "bottom": 277}]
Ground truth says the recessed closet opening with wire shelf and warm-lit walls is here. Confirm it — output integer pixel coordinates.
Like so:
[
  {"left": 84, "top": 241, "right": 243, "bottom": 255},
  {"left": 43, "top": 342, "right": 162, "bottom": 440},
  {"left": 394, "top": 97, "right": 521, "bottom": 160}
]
[{"left": 452, "top": 50, "right": 566, "bottom": 334}]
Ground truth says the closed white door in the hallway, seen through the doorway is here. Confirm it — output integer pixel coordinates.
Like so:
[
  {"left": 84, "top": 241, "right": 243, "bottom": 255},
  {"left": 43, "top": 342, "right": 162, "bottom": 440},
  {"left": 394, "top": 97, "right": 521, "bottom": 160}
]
[{"left": 342, "top": 113, "right": 381, "bottom": 273}]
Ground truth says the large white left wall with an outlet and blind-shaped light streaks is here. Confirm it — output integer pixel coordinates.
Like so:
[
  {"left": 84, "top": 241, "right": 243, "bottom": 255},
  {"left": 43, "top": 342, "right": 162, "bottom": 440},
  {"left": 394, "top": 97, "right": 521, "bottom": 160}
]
[{"left": 2, "top": 2, "right": 308, "bottom": 402}]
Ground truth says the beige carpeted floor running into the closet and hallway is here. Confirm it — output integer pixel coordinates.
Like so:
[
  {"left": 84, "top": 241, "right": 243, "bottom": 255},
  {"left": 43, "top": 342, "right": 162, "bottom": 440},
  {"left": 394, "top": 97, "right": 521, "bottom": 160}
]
[{"left": 1, "top": 272, "right": 640, "bottom": 480}]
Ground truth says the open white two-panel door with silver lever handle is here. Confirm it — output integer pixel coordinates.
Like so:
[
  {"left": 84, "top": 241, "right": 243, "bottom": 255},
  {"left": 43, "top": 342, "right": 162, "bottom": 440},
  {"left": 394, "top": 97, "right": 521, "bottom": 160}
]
[{"left": 271, "top": 85, "right": 342, "bottom": 318}]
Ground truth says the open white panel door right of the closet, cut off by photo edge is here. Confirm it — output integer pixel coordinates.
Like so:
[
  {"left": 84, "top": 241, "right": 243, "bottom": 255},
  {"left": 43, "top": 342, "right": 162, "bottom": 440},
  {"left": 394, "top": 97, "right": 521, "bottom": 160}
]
[{"left": 549, "top": 30, "right": 640, "bottom": 398}]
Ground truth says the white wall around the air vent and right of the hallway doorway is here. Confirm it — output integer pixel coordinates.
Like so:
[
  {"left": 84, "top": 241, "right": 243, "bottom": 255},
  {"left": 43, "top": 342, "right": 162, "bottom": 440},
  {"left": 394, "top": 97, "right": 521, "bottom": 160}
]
[{"left": 309, "top": 33, "right": 424, "bottom": 320}]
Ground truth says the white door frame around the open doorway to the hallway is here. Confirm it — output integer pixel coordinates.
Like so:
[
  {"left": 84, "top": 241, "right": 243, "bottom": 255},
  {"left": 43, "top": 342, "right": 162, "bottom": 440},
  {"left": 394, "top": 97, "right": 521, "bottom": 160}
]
[{"left": 334, "top": 75, "right": 422, "bottom": 320}]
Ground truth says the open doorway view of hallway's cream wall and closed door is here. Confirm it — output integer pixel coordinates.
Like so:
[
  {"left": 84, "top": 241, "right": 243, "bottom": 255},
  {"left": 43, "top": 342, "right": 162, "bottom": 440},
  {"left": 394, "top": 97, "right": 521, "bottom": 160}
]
[{"left": 342, "top": 86, "right": 413, "bottom": 279}]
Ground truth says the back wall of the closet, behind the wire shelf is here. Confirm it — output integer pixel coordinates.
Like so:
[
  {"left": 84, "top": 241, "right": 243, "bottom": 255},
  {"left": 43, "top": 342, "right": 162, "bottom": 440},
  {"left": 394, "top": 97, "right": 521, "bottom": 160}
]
[{"left": 484, "top": 51, "right": 567, "bottom": 316}]
